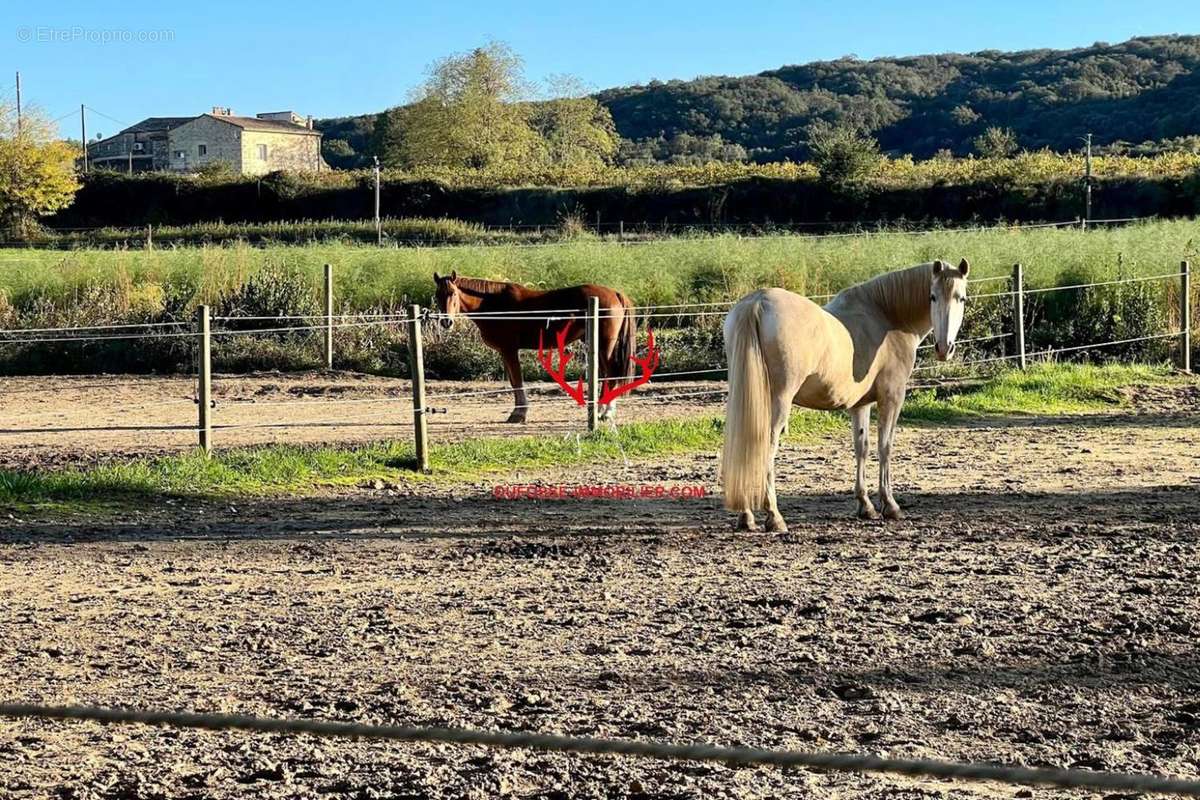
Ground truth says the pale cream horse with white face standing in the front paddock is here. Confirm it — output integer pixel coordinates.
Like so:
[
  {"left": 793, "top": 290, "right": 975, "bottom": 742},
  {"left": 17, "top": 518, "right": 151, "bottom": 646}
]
[{"left": 721, "top": 259, "right": 970, "bottom": 531}]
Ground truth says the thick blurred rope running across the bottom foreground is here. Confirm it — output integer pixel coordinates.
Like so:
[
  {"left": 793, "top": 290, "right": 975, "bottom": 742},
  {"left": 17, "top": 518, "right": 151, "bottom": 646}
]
[{"left": 0, "top": 703, "right": 1200, "bottom": 798}]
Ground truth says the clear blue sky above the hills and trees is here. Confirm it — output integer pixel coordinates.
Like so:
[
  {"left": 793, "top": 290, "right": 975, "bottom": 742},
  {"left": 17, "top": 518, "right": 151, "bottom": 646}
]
[{"left": 0, "top": 0, "right": 1200, "bottom": 138}]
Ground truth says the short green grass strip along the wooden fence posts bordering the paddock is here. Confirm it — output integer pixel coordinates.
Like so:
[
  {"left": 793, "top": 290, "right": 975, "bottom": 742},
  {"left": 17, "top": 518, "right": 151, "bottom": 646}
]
[{"left": 0, "top": 363, "right": 1188, "bottom": 507}]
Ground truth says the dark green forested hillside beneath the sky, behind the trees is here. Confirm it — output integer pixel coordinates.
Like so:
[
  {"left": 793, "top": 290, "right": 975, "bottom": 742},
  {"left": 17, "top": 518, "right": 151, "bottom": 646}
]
[{"left": 319, "top": 36, "right": 1200, "bottom": 167}]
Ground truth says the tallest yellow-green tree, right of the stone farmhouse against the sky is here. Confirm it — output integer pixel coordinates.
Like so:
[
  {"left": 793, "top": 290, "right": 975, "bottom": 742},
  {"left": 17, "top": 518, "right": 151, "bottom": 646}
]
[{"left": 380, "top": 42, "right": 540, "bottom": 169}]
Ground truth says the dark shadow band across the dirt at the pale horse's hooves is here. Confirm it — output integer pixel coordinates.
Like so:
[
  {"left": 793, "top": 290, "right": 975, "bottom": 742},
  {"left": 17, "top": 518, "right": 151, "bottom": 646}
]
[{"left": 11, "top": 483, "right": 1200, "bottom": 545}]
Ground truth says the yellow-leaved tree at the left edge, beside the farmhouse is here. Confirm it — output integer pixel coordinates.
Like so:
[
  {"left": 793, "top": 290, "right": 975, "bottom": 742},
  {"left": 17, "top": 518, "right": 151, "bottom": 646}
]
[{"left": 0, "top": 106, "right": 79, "bottom": 235}]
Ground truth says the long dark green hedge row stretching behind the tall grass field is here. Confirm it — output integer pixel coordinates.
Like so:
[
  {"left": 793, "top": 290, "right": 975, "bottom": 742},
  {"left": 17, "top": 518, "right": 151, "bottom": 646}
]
[{"left": 48, "top": 173, "right": 1200, "bottom": 227}]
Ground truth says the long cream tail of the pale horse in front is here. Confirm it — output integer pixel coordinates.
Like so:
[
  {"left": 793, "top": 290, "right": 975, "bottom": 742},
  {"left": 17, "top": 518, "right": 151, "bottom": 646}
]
[{"left": 721, "top": 296, "right": 770, "bottom": 511}]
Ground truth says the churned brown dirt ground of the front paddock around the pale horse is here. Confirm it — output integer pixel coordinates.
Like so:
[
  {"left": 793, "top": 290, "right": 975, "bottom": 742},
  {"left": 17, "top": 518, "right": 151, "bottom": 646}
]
[{"left": 0, "top": 376, "right": 1200, "bottom": 800}]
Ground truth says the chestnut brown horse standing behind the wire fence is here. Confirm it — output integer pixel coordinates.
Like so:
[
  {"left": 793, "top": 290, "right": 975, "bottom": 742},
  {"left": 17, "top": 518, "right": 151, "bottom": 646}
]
[{"left": 433, "top": 271, "right": 637, "bottom": 422}]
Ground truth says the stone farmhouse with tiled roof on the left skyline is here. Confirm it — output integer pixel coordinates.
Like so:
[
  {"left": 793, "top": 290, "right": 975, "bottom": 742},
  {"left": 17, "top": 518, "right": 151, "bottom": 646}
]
[{"left": 88, "top": 108, "right": 329, "bottom": 175}]
